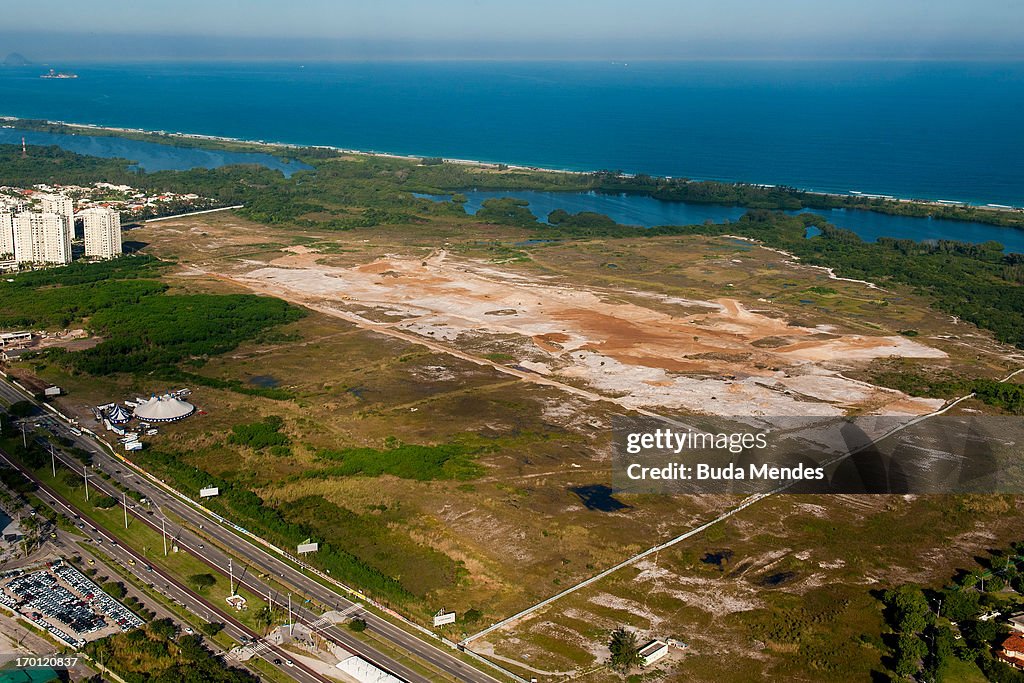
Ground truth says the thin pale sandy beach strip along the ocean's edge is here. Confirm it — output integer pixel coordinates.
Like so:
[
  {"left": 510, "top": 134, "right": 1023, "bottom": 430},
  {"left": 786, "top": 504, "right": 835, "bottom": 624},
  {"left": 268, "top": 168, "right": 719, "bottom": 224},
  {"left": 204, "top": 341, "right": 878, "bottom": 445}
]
[{"left": 0, "top": 115, "right": 1024, "bottom": 214}]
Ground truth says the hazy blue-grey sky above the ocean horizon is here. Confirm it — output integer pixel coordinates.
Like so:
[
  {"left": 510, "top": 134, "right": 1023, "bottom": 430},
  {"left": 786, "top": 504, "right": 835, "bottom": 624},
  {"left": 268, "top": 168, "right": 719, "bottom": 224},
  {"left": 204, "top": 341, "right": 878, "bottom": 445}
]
[{"left": 0, "top": 0, "right": 1024, "bottom": 60}]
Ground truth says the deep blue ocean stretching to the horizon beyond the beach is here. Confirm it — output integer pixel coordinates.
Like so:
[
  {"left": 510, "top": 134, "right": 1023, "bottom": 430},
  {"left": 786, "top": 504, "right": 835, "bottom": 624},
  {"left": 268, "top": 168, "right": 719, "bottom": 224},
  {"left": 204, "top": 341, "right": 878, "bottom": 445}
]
[{"left": 0, "top": 61, "right": 1024, "bottom": 206}]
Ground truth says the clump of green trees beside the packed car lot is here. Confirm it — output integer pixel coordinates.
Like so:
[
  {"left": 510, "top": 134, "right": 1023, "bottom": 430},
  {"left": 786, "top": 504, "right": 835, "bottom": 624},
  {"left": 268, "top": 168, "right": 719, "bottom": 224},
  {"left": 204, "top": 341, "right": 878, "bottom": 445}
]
[{"left": 84, "top": 620, "right": 259, "bottom": 683}]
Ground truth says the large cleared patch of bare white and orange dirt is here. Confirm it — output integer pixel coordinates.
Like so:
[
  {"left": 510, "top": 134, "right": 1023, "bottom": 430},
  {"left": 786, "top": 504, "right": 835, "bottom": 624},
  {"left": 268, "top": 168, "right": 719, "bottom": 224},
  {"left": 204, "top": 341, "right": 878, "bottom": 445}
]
[{"left": 219, "top": 245, "right": 946, "bottom": 416}]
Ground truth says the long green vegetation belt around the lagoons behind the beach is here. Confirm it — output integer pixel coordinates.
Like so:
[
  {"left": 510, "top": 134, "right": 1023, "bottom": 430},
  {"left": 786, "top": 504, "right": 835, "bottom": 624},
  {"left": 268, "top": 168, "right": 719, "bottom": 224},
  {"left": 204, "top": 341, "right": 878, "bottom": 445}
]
[{"left": 0, "top": 145, "right": 1024, "bottom": 356}]
